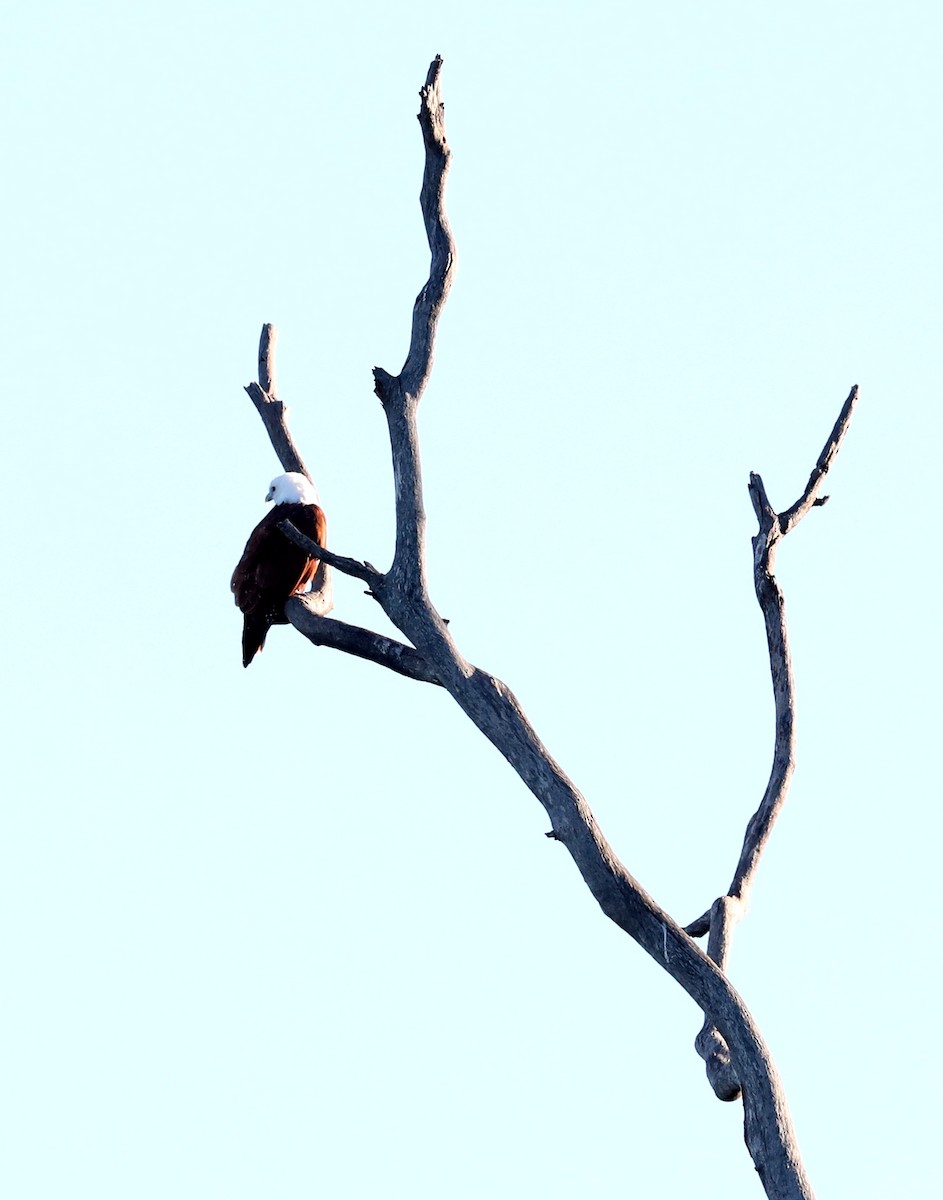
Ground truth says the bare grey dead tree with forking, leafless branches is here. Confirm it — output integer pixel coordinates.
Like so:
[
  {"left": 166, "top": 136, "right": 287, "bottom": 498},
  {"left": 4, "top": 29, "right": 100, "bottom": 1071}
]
[{"left": 237, "top": 58, "right": 858, "bottom": 1200}]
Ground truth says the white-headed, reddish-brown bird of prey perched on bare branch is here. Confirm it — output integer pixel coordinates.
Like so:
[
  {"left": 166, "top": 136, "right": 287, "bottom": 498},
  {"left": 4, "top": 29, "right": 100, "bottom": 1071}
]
[{"left": 232, "top": 470, "right": 328, "bottom": 667}]
